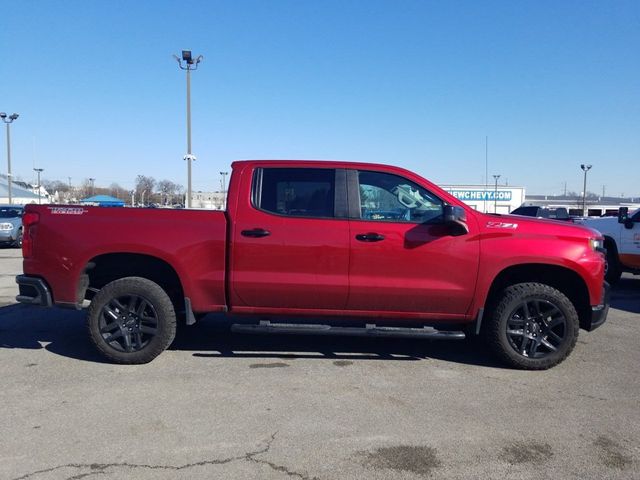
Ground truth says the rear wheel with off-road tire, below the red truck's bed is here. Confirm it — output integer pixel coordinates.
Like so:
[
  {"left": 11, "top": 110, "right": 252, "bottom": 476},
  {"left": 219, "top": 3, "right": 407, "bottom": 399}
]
[{"left": 87, "top": 277, "right": 176, "bottom": 364}]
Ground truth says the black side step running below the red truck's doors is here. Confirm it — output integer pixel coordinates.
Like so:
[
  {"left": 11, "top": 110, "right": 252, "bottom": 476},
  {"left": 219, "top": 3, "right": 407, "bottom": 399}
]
[{"left": 231, "top": 320, "right": 465, "bottom": 340}]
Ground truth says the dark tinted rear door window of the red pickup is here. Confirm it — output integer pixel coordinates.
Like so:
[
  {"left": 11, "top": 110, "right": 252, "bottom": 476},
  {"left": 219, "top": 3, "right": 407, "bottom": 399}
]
[{"left": 253, "top": 168, "right": 335, "bottom": 218}]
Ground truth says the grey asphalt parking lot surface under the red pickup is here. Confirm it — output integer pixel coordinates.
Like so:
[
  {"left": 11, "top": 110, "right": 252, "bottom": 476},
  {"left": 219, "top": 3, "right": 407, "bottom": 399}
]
[{"left": 0, "top": 248, "right": 640, "bottom": 480}]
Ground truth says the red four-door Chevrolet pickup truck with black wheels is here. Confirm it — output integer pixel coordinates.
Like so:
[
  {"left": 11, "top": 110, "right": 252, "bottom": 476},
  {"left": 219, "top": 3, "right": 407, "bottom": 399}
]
[{"left": 16, "top": 160, "right": 608, "bottom": 369}]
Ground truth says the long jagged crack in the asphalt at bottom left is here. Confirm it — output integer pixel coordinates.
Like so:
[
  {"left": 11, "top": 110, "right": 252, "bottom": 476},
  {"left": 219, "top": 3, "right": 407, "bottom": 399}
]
[{"left": 13, "top": 432, "right": 319, "bottom": 480}]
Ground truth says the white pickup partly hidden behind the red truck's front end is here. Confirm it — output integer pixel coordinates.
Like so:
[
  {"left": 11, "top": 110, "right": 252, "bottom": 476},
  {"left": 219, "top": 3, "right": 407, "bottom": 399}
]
[{"left": 576, "top": 207, "right": 640, "bottom": 284}]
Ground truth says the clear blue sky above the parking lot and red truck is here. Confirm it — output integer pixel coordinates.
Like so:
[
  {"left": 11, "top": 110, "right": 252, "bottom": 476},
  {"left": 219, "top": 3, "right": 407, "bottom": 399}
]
[{"left": 0, "top": 0, "right": 640, "bottom": 196}]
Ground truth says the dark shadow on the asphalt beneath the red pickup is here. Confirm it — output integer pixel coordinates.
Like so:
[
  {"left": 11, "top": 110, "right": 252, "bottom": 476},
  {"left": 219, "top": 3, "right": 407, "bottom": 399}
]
[{"left": 0, "top": 305, "right": 503, "bottom": 368}]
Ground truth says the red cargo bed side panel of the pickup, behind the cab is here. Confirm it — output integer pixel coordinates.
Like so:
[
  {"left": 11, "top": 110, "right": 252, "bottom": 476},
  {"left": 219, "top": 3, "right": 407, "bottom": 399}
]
[{"left": 24, "top": 205, "right": 227, "bottom": 312}]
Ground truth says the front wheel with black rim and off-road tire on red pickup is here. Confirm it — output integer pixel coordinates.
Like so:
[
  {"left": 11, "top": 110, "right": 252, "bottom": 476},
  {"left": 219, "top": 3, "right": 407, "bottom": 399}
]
[{"left": 484, "top": 283, "right": 580, "bottom": 370}]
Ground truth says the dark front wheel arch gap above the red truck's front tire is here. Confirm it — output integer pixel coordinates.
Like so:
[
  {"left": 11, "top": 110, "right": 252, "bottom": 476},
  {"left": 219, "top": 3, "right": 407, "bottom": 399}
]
[{"left": 485, "top": 264, "right": 591, "bottom": 328}]
